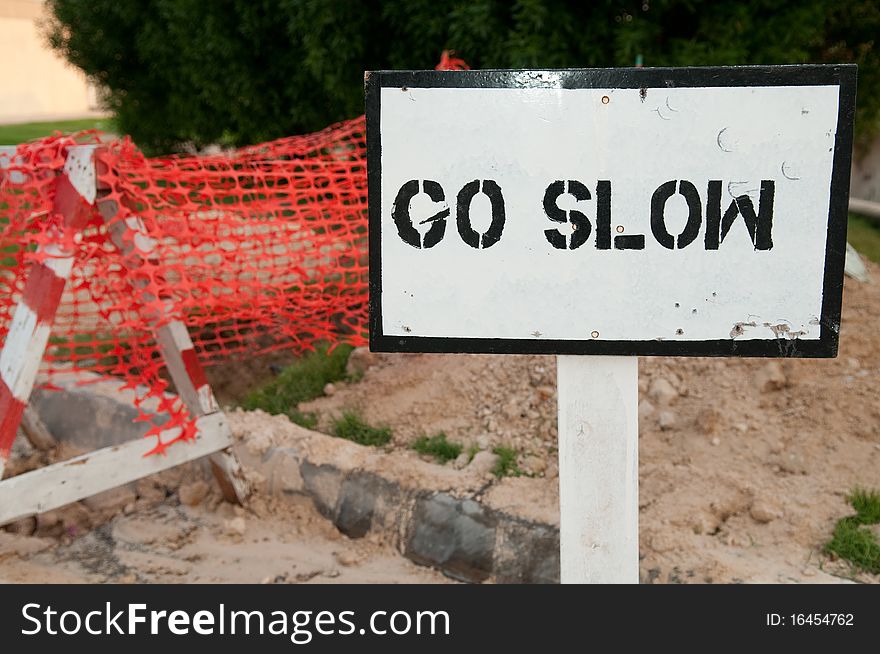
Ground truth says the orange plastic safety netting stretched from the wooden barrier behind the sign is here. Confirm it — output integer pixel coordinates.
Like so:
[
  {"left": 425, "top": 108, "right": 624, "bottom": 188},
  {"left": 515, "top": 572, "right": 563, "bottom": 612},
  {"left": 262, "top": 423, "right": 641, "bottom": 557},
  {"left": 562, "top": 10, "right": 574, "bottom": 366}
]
[{"left": 0, "top": 117, "right": 368, "bottom": 451}]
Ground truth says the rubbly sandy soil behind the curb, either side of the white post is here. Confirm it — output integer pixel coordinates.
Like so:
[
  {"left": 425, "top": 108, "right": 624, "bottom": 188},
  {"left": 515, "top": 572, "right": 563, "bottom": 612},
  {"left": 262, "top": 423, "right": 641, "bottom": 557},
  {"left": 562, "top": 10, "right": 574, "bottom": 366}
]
[{"left": 301, "top": 265, "right": 880, "bottom": 582}]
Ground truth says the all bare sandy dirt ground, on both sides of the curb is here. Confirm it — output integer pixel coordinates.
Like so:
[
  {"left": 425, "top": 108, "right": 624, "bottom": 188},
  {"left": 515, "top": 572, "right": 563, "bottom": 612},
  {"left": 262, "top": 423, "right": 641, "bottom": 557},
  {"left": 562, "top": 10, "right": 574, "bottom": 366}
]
[{"left": 0, "top": 265, "right": 880, "bottom": 583}]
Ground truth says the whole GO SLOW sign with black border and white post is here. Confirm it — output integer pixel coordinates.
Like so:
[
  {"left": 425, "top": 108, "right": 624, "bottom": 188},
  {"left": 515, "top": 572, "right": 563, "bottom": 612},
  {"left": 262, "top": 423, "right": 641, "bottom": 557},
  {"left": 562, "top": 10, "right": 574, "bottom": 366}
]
[{"left": 366, "top": 65, "right": 856, "bottom": 582}]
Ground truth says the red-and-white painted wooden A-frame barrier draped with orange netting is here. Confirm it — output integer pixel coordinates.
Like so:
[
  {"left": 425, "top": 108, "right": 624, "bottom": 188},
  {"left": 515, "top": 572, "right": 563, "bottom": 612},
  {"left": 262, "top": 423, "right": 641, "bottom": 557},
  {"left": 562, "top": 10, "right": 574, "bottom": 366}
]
[{"left": 0, "top": 146, "right": 249, "bottom": 525}]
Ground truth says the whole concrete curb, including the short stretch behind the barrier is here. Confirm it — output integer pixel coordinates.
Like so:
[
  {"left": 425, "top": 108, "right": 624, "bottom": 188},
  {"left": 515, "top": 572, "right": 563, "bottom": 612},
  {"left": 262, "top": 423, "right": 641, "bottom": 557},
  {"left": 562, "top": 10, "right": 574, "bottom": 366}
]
[{"left": 27, "top": 382, "right": 559, "bottom": 583}]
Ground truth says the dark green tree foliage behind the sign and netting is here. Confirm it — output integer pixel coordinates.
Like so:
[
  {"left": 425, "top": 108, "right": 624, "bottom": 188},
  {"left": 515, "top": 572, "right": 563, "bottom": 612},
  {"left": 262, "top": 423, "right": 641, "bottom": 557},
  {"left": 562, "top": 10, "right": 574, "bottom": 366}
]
[{"left": 46, "top": 0, "right": 880, "bottom": 152}]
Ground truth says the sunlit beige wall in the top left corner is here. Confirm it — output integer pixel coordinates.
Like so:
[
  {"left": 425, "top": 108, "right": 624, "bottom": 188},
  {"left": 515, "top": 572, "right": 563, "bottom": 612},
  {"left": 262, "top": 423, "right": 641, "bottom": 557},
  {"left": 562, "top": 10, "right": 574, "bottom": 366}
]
[{"left": 0, "top": 0, "right": 97, "bottom": 123}]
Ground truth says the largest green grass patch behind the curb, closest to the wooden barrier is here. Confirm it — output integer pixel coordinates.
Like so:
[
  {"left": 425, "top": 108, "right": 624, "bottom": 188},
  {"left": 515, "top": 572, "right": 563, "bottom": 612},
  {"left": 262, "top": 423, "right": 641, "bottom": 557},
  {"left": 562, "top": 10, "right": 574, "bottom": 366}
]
[{"left": 241, "top": 345, "right": 354, "bottom": 429}]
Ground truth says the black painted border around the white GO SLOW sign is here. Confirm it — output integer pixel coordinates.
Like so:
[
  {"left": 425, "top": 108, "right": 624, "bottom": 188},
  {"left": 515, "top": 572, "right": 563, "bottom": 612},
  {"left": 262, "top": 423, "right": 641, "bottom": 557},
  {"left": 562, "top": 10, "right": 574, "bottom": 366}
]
[{"left": 364, "top": 64, "right": 857, "bottom": 358}]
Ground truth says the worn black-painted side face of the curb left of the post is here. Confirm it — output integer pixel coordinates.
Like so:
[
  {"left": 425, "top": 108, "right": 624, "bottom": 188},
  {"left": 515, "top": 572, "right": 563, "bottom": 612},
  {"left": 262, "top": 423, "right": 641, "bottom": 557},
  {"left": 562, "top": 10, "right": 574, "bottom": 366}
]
[{"left": 258, "top": 456, "right": 559, "bottom": 583}]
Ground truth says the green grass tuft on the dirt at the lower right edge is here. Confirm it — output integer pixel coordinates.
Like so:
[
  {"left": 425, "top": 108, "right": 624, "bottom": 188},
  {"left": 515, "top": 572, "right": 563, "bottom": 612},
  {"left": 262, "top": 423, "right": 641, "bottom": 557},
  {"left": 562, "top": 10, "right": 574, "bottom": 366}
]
[{"left": 825, "top": 488, "right": 880, "bottom": 575}]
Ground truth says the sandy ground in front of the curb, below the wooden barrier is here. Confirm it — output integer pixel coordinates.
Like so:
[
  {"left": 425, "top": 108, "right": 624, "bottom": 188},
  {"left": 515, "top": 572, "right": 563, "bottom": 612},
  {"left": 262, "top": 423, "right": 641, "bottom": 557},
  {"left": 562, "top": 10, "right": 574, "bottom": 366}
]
[{"left": 0, "top": 466, "right": 449, "bottom": 583}]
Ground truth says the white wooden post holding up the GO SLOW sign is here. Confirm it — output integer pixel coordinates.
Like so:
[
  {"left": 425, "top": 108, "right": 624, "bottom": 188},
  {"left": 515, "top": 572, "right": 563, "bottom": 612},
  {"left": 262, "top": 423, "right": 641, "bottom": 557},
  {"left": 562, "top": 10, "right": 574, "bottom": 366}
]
[{"left": 556, "top": 355, "right": 639, "bottom": 584}]
